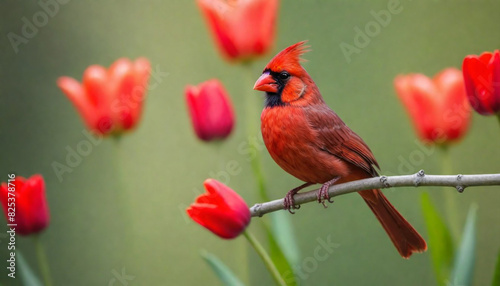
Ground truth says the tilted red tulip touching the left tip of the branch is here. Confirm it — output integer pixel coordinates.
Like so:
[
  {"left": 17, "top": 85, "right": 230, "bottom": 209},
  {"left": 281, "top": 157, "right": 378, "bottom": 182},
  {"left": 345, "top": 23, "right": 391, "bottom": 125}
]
[{"left": 186, "top": 179, "right": 250, "bottom": 239}]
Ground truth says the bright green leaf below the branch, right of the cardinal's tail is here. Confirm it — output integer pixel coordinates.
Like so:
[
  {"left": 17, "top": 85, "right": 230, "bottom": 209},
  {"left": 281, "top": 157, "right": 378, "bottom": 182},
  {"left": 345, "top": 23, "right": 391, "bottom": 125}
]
[{"left": 422, "top": 193, "right": 454, "bottom": 285}]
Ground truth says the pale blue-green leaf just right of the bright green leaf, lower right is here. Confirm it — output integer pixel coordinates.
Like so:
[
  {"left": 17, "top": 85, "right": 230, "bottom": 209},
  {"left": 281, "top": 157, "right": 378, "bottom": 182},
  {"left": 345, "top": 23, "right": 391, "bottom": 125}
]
[{"left": 450, "top": 204, "right": 477, "bottom": 286}]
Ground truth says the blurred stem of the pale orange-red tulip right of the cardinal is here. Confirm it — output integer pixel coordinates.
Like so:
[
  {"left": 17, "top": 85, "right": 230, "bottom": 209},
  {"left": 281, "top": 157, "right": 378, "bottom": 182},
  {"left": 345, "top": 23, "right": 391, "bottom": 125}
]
[{"left": 441, "top": 146, "right": 460, "bottom": 241}]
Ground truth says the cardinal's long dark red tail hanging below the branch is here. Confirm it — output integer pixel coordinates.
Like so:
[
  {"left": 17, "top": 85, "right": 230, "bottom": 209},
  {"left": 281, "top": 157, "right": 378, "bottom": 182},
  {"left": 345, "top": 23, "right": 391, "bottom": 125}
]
[{"left": 359, "top": 190, "right": 427, "bottom": 258}]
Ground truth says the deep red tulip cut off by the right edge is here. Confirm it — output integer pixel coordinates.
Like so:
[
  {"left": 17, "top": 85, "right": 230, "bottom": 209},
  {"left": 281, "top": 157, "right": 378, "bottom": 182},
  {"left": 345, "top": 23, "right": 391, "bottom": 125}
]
[{"left": 462, "top": 50, "right": 500, "bottom": 115}]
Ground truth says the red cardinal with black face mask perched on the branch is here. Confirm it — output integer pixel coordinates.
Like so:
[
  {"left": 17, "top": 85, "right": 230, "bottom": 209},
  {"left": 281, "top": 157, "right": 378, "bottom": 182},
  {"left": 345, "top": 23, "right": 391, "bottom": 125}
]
[{"left": 254, "top": 42, "right": 427, "bottom": 258}]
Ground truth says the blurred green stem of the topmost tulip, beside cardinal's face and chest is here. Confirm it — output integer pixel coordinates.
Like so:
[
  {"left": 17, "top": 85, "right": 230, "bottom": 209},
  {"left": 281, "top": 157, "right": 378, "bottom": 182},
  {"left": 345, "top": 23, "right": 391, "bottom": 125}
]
[{"left": 244, "top": 62, "right": 269, "bottom": 201}]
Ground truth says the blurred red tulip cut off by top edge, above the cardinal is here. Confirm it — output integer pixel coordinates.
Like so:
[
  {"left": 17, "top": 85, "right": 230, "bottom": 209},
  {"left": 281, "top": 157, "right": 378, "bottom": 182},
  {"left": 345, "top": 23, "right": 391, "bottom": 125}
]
[{"left": 197, "top": 0, "right": 279, "bottom": 60}]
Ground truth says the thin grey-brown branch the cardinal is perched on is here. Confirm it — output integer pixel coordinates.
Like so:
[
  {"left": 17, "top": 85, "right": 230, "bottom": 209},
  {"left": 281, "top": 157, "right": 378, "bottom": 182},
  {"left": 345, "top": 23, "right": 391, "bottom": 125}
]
[{"left": 250, "top": 170, "right": 500, "bottom": 217}]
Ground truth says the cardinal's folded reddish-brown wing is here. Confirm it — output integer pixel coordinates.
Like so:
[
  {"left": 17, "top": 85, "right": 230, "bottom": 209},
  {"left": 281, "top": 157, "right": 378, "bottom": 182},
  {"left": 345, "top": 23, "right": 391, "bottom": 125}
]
[{"left": 304, "top": 105, "right": 379, "bottom": 176}]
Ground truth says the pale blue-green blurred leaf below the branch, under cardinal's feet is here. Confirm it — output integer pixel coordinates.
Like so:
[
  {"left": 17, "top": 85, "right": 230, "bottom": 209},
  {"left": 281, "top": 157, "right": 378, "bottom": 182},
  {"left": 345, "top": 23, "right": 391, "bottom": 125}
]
[{"left": 269, "top": 211, "right": 300, "bottom": 265}]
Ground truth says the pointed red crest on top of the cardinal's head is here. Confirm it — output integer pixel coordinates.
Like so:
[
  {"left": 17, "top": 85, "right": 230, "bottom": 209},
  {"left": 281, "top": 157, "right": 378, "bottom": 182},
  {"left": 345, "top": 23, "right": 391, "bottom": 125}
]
[{"left": 266, "top": 41, "right": 310, "bottom": 73}]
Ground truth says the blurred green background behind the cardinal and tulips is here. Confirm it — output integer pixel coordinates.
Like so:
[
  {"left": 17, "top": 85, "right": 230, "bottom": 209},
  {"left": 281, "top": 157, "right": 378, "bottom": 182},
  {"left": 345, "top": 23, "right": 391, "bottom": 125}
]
[{"left": 0, "top": 0, "right": 500, "bottom": 285}]
